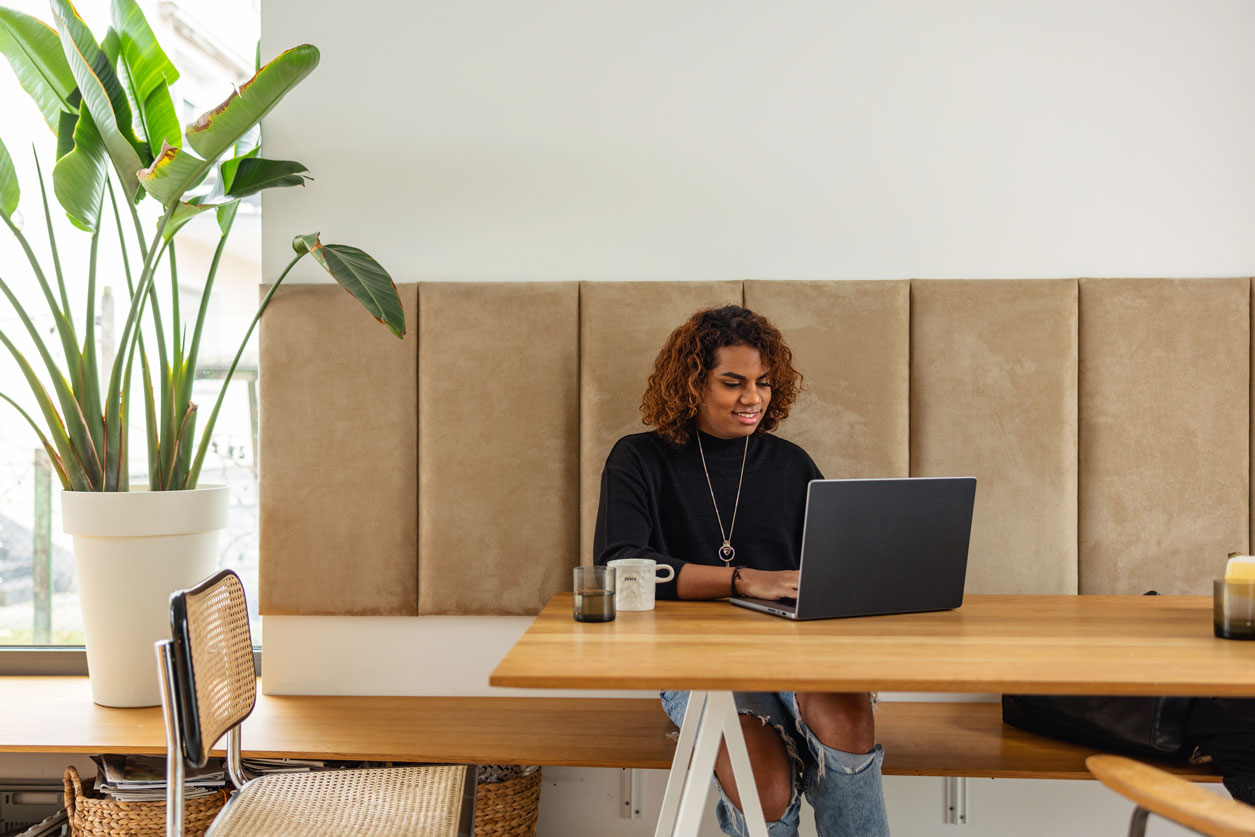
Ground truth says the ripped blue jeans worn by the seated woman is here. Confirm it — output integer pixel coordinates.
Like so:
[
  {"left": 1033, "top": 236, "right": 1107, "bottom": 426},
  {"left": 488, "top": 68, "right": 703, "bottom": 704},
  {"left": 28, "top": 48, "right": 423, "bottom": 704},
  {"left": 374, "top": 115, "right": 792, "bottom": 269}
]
[{"left": 661, "top": 691, "right": 889, "bottom": 837}]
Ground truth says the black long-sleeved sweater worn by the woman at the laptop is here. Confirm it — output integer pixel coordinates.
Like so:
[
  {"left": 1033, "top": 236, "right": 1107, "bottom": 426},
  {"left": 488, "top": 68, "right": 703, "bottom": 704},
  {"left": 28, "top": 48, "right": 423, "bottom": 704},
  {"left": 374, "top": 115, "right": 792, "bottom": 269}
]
[{"left": 592, "top": 433, "right": 823, "bottom": 599}]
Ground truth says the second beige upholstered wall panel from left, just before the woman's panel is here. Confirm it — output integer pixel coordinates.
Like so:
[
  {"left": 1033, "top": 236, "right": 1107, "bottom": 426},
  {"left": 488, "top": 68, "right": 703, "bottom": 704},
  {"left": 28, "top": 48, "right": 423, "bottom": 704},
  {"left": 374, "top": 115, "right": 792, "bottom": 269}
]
[{"left": 418, "top": 282, "right": 580, "bottom": 614}]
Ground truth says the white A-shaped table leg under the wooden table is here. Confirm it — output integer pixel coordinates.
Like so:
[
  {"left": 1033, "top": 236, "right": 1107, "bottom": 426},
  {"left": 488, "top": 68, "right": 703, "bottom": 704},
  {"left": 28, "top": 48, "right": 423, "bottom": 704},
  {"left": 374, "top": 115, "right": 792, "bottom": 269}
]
[{"left": 654, "top": 691, "right": 767, "bottom": 837}]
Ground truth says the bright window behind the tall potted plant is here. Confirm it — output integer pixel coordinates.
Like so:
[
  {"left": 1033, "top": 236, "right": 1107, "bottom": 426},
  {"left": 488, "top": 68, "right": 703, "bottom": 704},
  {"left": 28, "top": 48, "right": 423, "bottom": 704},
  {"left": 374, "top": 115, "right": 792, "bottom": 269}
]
[{"left": 0, "top": 0, "right": 262, "bottom": 648}]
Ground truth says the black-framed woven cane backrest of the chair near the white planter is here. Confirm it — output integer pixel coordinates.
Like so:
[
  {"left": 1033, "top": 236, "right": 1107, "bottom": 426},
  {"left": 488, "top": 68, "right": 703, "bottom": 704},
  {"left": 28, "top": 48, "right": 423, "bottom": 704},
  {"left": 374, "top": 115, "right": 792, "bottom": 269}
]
[{"left": 169, "top": 570, "right": 257, "bottom": 767}]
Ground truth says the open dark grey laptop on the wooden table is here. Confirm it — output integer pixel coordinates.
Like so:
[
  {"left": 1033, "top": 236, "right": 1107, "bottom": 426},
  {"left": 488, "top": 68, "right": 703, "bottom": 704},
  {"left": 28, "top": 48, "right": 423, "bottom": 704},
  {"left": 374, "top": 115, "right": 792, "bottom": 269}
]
[{"left": 729, "top": 477, "right": 976, "bottom": 620}]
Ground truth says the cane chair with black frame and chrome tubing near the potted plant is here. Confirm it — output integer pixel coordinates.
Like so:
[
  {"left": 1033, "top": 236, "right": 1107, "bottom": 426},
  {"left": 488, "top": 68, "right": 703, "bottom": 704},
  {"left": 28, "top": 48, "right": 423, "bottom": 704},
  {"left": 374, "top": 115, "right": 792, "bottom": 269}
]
[{"left": 157, "top": 570, "right": 476, "bottom": 837}]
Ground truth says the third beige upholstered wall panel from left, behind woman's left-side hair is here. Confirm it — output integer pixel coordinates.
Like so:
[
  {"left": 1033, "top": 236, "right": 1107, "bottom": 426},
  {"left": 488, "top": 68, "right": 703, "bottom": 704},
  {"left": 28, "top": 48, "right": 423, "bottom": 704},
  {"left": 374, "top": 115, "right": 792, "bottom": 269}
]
[{"left": 580, "top": 281, "right": 742, "bottom": 563}]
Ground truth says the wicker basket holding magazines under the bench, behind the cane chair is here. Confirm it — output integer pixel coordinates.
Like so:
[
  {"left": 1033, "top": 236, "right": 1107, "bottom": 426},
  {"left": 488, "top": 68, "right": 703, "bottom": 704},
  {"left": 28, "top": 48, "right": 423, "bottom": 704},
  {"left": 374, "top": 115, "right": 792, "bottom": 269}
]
[{"left": 63, "top": 767, "right": 228, "bottom": 837}]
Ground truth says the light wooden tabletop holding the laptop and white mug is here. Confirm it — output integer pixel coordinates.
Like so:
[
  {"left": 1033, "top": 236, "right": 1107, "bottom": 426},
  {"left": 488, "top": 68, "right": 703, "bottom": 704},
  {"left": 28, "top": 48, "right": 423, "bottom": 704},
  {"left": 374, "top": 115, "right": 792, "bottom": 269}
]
[{"left": 488, "top": 594, "right": 1255, "bottom": 696}]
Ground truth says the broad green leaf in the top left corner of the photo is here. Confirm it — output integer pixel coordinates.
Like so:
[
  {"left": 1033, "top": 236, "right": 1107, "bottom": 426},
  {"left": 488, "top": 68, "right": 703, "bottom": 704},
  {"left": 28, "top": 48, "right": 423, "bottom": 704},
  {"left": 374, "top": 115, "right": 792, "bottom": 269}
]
[{"left": 0, "top": 6, "right": 77, "bottom": 131}]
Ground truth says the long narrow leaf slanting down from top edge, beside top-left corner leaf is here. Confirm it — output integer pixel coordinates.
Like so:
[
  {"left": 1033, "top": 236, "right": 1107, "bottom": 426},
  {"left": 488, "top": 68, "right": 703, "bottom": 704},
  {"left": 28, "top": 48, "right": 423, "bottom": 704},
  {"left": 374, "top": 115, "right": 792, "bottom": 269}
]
[{"left": 51, "top": 0, "right": 146, "bottom": 200}]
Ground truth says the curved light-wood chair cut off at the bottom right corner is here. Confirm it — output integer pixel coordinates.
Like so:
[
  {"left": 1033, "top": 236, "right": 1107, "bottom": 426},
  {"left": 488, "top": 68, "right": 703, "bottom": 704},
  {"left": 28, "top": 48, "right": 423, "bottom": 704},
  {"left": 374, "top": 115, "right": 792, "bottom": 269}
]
[{"left": 1086, "top": 754, "right": 1255, "bottom": 837}]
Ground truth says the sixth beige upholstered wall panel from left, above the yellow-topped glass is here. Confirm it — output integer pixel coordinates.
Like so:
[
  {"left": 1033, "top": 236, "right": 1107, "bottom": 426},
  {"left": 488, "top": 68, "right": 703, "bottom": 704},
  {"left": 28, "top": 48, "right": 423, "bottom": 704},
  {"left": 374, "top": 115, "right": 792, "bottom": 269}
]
[{"left": 1081, "top": 279, "right": 1251, "bottom": 595}]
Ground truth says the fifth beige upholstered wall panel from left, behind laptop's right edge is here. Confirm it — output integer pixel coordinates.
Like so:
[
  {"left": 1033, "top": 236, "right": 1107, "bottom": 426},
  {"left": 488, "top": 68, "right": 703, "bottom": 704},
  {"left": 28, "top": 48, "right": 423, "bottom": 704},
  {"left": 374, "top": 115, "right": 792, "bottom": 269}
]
[{"left": 911, "top": 280, "right": 1077, "bottom": 594}]
